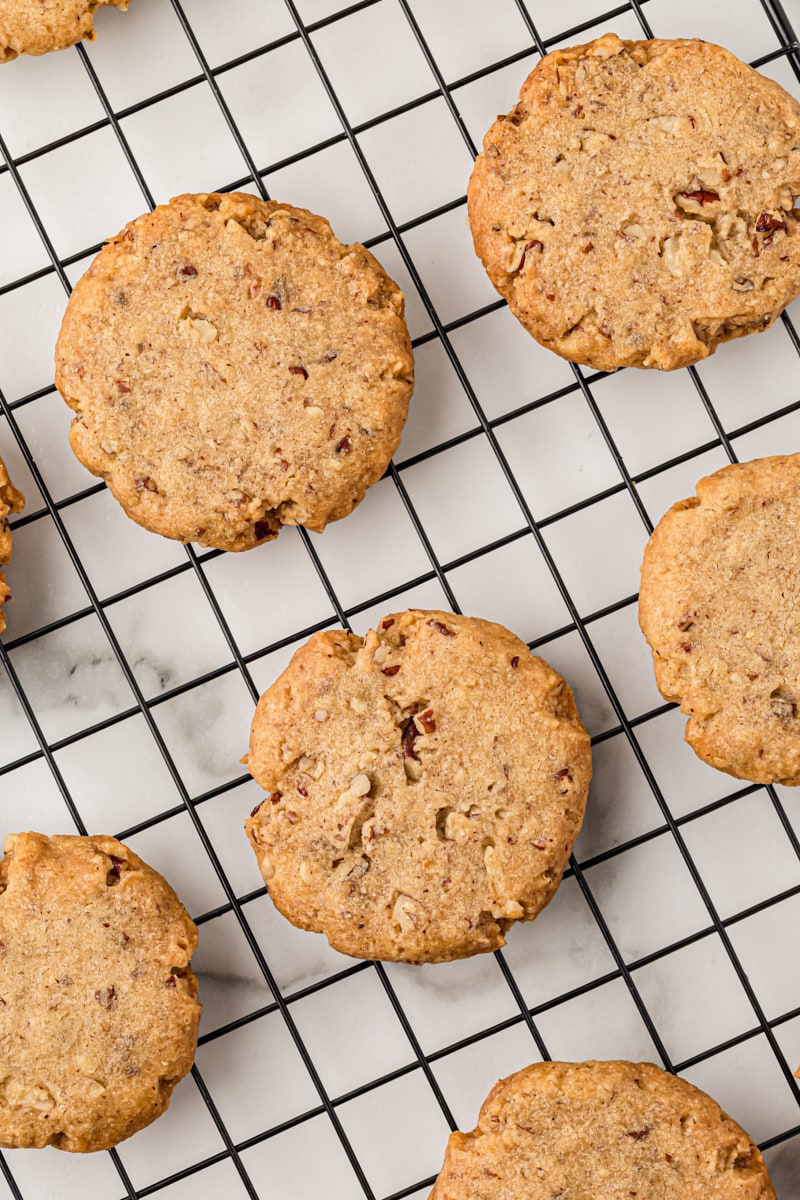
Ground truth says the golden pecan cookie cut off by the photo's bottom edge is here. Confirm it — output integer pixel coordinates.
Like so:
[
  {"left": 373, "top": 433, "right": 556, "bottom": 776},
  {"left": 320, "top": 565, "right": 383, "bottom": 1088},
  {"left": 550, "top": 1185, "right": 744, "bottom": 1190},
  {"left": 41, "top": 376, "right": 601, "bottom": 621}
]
[{"left": 431, "top": 1062, "right": 775, "bottom": 1200}]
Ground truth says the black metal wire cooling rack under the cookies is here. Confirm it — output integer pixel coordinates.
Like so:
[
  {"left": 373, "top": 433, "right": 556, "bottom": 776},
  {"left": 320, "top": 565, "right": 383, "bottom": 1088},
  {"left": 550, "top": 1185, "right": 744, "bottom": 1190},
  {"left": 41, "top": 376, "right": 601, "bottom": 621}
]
[{"left": 0, "top": 0, "right": 800, "bottom": 1200}]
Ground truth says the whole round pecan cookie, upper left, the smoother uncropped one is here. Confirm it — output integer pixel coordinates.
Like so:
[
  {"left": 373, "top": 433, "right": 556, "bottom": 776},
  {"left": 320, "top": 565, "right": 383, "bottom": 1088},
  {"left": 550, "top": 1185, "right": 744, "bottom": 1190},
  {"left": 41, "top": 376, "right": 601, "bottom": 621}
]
[{"left": 56, "top": 193, "right": 413, "bottom": 550}]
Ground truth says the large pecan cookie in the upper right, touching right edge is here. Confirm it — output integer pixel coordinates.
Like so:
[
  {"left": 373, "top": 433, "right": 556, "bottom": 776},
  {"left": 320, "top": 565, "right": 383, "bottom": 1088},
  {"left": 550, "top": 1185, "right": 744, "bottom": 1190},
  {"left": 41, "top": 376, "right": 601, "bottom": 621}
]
[{"left": 468, "top": 34, "right": 800, "bottom": 371}]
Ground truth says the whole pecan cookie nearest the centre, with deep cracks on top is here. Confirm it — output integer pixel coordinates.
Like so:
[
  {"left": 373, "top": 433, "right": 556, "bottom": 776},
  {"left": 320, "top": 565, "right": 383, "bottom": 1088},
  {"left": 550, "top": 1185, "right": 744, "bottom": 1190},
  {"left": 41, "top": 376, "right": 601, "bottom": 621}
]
[{"left": 246, "top": 611, "right": 591, "bottom": 962}]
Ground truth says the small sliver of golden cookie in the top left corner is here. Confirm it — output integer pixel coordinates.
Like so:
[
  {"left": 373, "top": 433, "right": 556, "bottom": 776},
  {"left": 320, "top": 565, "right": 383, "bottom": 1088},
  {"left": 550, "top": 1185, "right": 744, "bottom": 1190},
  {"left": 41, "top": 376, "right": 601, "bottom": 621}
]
[{"left": 0, "top": 0, "right": 130, "bottom": 62}]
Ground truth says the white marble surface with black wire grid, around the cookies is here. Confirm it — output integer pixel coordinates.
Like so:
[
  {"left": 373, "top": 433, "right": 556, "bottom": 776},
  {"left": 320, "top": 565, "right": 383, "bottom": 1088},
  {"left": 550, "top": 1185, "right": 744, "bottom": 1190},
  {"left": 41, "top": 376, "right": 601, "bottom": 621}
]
[{"left": 0, "top": 0, "right": 800, "bottom": 1200}]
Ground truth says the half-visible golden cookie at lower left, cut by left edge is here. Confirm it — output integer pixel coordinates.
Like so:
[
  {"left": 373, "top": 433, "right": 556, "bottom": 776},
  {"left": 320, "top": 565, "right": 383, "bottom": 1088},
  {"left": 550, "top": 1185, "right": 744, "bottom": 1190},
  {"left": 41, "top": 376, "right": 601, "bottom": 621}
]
[{"left": 0, "top": 833, "right": 200, "bottom": 1151}]
